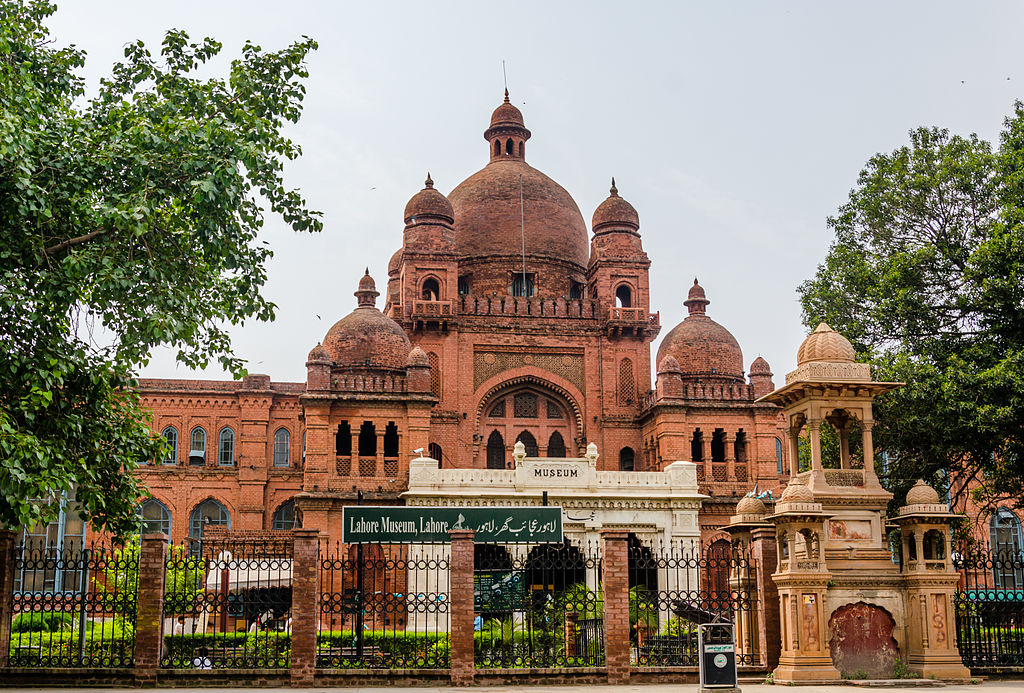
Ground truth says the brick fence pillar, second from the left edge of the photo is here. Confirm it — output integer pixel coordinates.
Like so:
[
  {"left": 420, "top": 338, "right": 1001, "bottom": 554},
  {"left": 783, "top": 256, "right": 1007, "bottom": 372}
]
[{"left": 135, "top": 532, "right": 167, "bottom": 687}]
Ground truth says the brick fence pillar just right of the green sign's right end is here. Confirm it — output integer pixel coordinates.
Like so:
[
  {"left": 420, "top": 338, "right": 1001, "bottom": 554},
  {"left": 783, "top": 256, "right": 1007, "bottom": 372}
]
[{"left": 601, "top": 529, "right": 630, "bottom": 685}]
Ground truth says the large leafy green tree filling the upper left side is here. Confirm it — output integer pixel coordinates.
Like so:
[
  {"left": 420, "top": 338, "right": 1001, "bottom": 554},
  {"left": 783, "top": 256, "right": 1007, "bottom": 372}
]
[{"left": 0, "top": 0, "right": 321, "bottom": 534}]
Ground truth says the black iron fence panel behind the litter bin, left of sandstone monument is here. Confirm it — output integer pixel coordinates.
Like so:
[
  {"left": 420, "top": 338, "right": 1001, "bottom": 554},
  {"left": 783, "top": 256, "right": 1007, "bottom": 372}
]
[{"left": 629, "top": 540, "right": 760, "bottom": 666}]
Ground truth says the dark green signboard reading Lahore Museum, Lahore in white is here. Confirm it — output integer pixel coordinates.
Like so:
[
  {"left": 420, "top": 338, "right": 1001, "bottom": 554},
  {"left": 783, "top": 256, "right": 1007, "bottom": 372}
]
[{"left": 341, "top": 506, "right": 562, "bottom": 544}]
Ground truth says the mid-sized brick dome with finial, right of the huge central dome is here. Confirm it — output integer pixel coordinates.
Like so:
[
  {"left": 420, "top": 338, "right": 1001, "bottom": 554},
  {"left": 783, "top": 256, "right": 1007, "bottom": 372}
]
[{"left": 657, "top": 279, "right": 743, "bottom": 381}]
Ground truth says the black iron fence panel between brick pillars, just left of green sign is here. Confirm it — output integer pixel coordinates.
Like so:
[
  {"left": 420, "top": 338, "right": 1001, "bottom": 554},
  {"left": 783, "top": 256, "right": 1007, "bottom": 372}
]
[{"left": 160, "top": 540, "right": 292, "bottom": 669}]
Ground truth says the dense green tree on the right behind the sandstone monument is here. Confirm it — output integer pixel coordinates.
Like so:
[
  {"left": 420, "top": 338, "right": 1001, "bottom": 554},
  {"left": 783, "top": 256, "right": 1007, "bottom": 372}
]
[{"left": 800, "top": 102, "right": 1024, "bottom": 511}]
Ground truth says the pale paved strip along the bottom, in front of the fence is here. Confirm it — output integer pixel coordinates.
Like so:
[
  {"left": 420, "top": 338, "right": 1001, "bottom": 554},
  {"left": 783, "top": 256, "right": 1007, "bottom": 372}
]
[{"left": 0, "top": 680, "right": 1024, "bottom": 693}]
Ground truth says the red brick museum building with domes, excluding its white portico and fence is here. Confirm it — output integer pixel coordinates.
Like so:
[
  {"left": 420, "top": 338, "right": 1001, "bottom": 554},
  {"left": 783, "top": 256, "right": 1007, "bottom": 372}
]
[{"left": 139, "top": 96, "right": 790, "bottom": 542}]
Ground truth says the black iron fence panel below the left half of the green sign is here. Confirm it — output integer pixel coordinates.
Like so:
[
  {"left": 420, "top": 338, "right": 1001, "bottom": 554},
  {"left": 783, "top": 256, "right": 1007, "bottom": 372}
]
[{"left": 316, "top": 544, "right": 451, "bottom": 668}]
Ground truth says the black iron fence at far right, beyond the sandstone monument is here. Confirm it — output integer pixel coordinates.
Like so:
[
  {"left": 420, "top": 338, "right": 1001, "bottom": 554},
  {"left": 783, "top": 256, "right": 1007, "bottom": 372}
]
[{"left": 952, "top": 546, "right": 1024, "bottom": 669}]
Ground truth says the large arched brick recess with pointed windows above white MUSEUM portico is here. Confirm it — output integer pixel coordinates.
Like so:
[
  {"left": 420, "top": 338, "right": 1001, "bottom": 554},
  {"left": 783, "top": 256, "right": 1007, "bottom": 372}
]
[{"left": 479, "top": 385, "right": 577, "bottom": 462}]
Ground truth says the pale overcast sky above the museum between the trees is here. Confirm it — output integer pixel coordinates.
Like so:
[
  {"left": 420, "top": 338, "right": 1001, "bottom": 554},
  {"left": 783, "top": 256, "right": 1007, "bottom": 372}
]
[{"left": 50, "top": 0, "right": 1024, "bottom": 384}]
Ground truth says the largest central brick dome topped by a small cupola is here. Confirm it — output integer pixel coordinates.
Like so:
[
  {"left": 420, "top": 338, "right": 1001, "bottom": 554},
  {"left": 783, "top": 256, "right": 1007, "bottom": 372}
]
[{"left": 447, "top": 92, "right": 590, "bottom": 271}]
